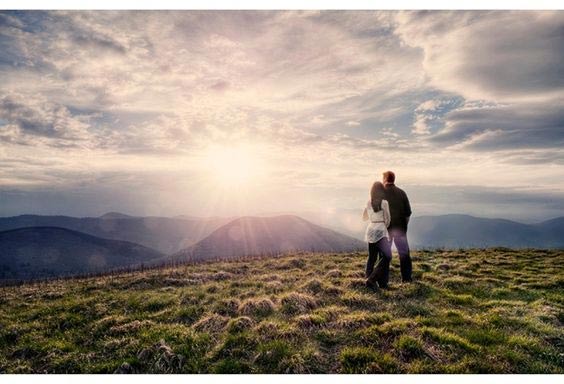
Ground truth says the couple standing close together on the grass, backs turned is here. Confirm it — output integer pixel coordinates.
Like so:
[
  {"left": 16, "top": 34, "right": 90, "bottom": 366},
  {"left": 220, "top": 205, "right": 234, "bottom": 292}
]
[{"left": 362, "top": 171, "right": 411, "bottom": 289}]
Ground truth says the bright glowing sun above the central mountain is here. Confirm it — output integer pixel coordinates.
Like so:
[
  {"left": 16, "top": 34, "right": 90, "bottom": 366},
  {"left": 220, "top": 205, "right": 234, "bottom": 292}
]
[{"left": 202, "top": 144, "right": 265, "bottom": 188}]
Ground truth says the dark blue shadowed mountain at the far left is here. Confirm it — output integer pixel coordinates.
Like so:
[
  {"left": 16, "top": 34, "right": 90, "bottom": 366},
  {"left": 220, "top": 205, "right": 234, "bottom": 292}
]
[{"left": 0, "top": 227, "right": 164, "bottom": 280}]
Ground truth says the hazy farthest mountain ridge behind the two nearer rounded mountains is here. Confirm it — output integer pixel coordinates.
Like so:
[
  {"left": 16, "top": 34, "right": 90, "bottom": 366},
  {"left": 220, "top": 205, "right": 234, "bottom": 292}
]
[{"left": 0, "top": 212, "right": 564, "bottom": 254}]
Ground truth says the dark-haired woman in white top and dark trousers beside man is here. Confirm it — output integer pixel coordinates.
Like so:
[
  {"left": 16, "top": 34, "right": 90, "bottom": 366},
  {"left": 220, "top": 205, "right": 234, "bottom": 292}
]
[{"left": 362, "top": 181, "right": 392, "bottom": 289}]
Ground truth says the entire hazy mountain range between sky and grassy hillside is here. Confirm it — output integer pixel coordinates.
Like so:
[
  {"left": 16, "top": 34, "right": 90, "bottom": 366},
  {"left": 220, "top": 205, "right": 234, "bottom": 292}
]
[{"left": 0, "top": 212, "right": 564, "bottom": 281}]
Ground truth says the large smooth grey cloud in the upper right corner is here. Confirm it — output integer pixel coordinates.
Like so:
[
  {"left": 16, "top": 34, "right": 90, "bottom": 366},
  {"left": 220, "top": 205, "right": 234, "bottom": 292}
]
[{"left": 396, "top": 11, "right": 564, "bottom": 101}]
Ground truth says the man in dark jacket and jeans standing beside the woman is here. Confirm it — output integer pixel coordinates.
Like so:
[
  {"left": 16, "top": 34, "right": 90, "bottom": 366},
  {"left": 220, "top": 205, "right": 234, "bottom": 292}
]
[{"left": 383, "top": 171, "right": 412, "bottom": 283}]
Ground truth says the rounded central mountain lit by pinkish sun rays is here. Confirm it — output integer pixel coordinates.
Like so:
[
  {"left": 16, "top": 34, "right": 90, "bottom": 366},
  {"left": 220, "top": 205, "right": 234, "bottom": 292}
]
[{"left": 172, "top": 215, "right": 366, "bottom": 261}]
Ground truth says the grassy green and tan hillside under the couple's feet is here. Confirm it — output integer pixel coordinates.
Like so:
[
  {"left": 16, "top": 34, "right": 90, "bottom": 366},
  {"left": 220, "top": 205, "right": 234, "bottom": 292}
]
[{"left": 0, "top": 249, "right": 564, "bottom": 373}]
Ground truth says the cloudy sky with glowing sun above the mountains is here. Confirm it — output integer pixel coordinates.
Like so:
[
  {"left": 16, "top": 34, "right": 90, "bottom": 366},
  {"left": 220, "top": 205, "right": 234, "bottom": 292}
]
[{"left": 0, "top": 10, "right": 564, "bottom": 222}]
